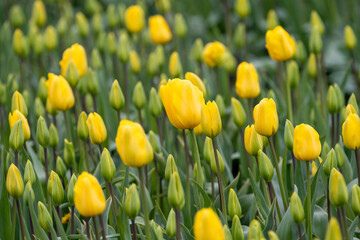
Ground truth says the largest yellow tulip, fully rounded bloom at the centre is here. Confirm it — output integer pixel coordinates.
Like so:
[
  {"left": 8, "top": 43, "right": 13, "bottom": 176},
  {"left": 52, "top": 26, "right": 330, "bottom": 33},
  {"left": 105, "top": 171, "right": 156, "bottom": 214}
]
[{"left": 160, "top": 78, "right": 204, "bottom": 129}]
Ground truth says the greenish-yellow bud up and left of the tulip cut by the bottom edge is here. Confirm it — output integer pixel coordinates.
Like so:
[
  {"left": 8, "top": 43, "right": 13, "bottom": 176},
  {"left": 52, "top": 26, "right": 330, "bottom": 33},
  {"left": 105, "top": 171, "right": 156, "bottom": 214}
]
[{"left": 168, "top": 172, "right": 185, "bottom": 210}]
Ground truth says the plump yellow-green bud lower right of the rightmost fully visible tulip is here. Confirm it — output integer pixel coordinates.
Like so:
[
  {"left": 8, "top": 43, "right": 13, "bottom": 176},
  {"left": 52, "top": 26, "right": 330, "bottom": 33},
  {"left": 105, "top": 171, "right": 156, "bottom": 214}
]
[{"left": 329, "top": 168, "right": 349, "bottom": 208}]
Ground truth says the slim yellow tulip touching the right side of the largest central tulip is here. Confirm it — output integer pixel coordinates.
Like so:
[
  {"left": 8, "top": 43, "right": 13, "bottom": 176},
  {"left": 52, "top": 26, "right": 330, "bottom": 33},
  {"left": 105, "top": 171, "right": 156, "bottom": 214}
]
[{"left": 201, "top": 101, "right": 221, "bottom": 138}]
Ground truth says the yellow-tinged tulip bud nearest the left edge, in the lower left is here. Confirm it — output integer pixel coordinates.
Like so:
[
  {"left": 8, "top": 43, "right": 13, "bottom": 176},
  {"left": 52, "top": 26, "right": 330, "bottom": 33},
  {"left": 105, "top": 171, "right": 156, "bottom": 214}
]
[{"left": 6, "top": 163, "right": 24, "bottom": 199}]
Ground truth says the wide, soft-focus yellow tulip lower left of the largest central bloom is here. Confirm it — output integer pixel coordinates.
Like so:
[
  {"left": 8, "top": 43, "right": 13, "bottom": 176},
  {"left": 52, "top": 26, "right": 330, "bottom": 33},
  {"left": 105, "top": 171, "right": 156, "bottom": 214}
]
[{"left": 115, "top": 119, "right": 154, "bottom": 167}]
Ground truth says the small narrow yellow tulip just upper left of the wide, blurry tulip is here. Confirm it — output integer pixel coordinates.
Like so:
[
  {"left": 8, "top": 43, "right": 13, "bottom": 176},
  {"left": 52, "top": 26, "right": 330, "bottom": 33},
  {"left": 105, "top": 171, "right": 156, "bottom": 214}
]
[{"left": 86, "top": 112, "right": 107, "bottom": 144}]
